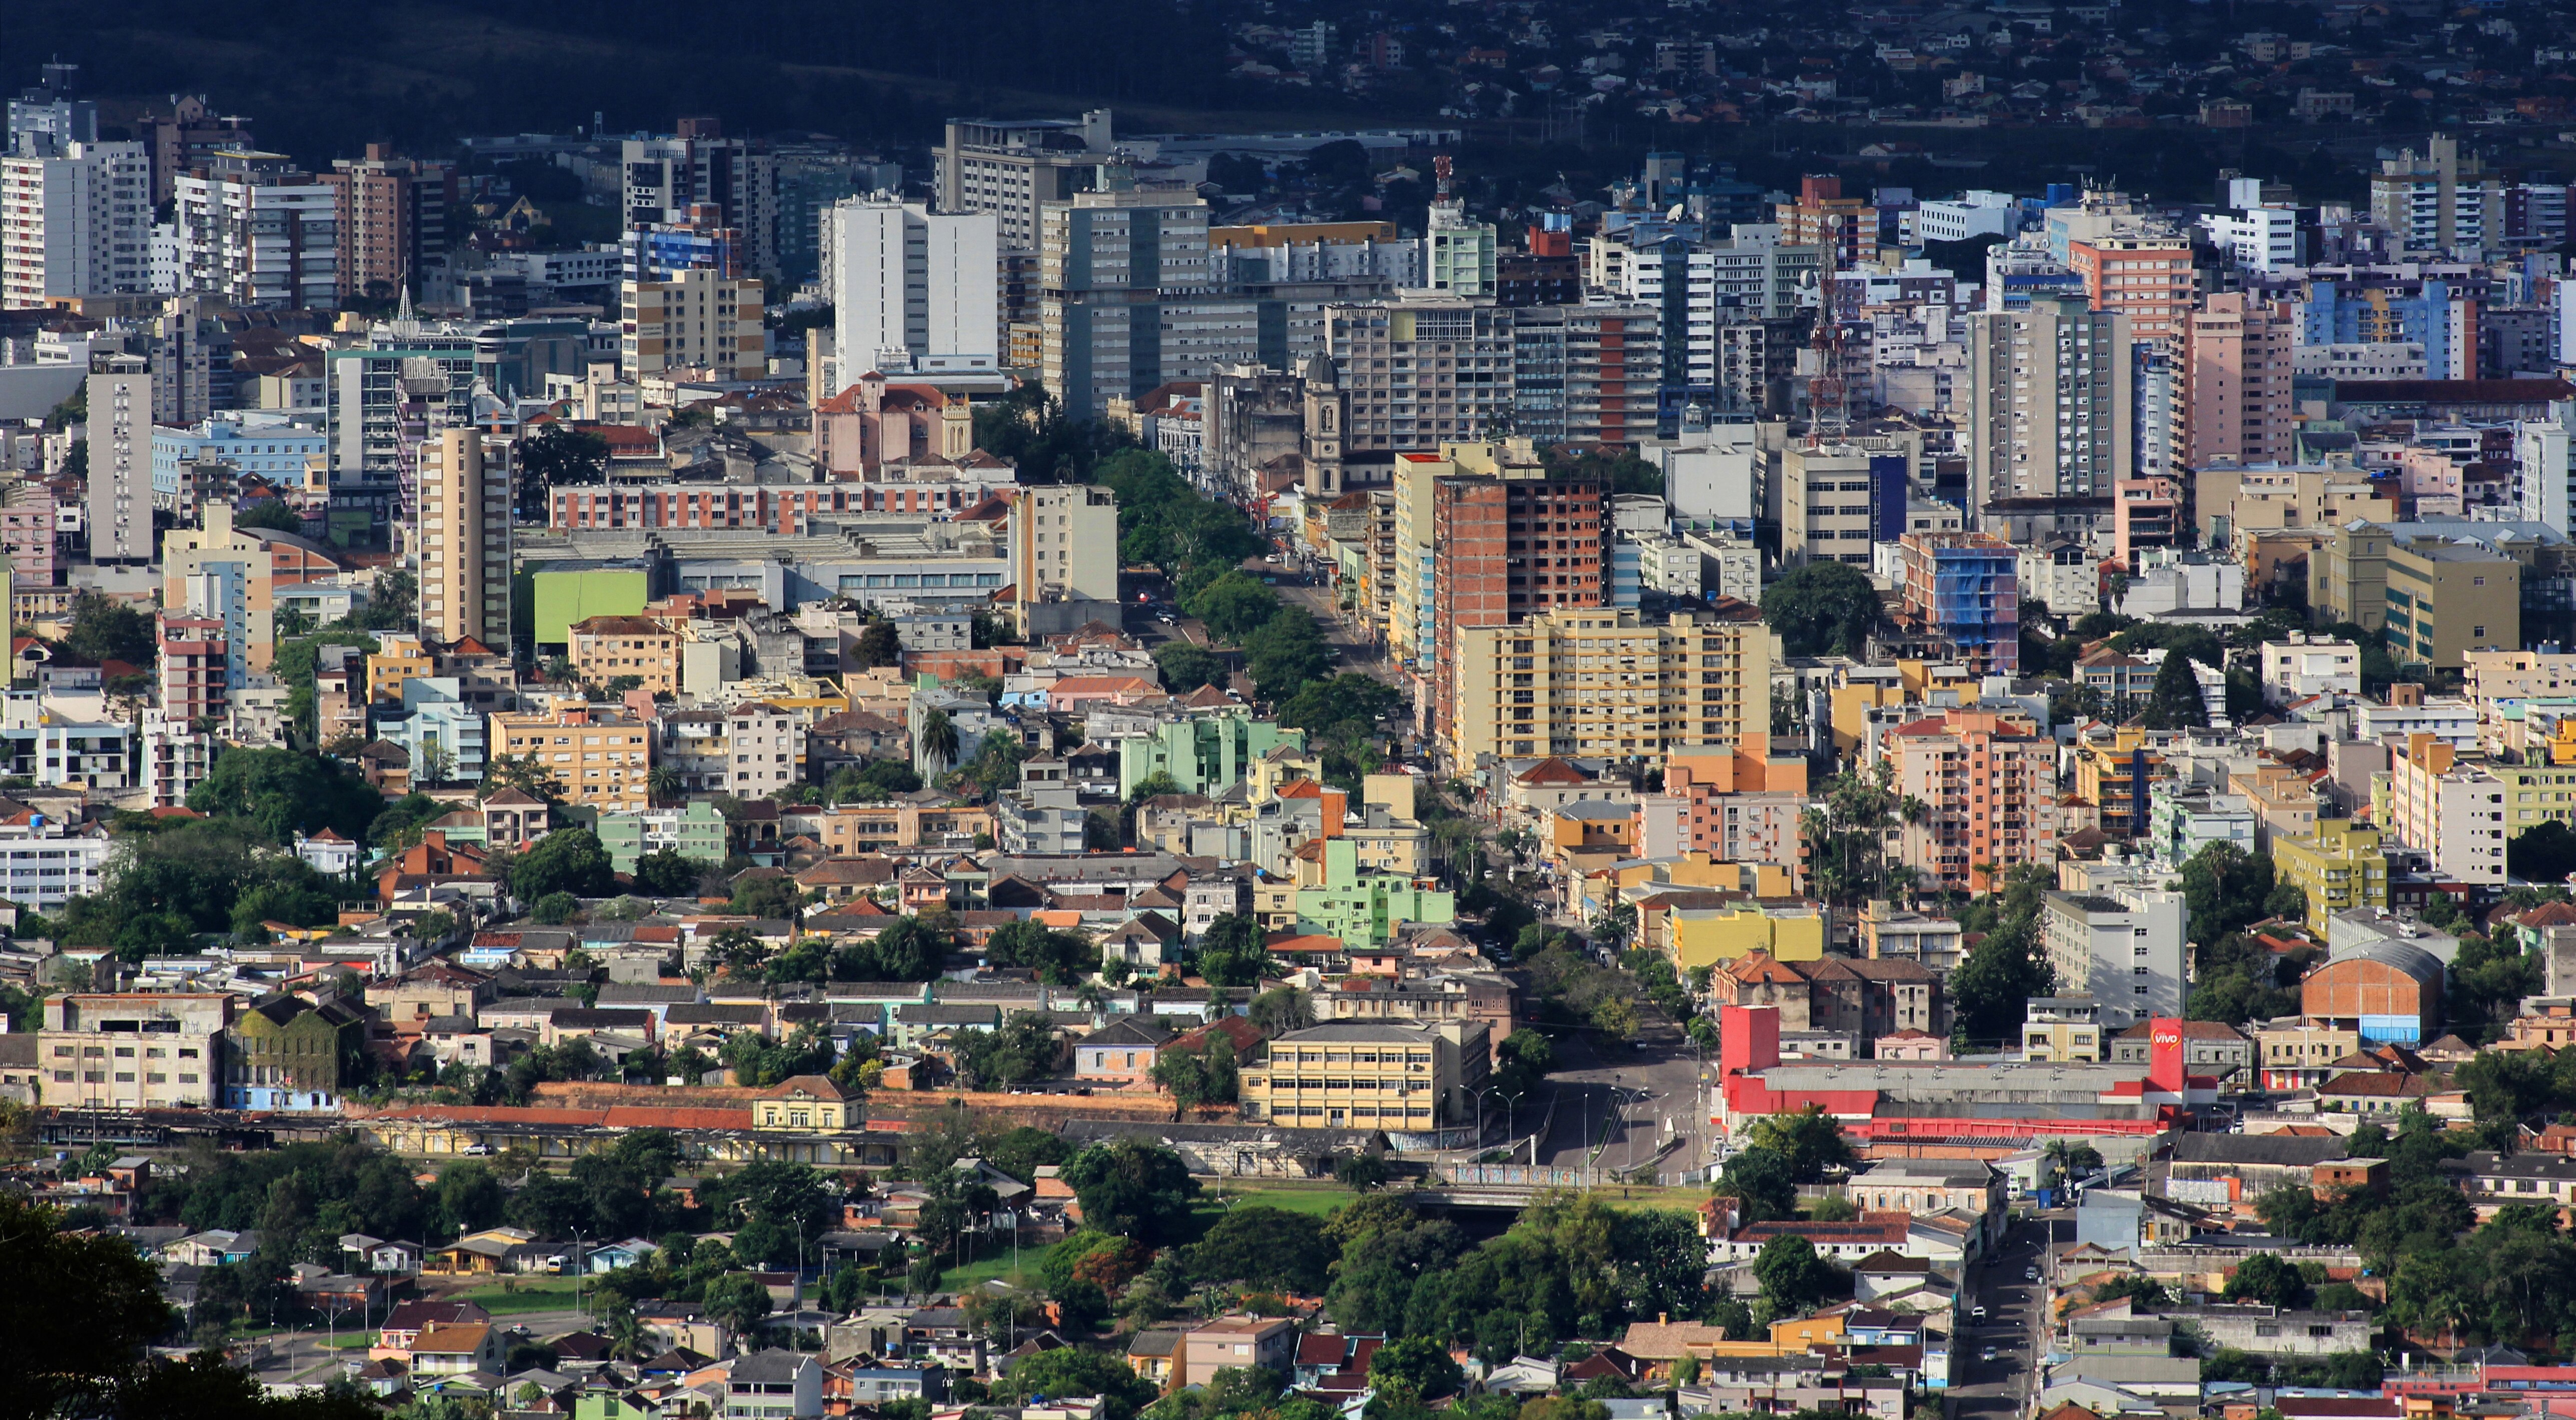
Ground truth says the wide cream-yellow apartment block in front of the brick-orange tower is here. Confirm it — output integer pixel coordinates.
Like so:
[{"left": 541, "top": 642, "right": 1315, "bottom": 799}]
[{"left": 1443, "top": 603, "right": 1770, "bottom": 768}]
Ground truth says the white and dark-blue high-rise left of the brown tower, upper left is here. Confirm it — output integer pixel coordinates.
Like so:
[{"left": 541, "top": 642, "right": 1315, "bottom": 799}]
[{"left": 173, "top": 150, "right": 340, "bottom": 309}]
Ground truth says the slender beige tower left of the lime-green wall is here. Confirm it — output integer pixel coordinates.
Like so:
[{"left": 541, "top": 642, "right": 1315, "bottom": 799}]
[{"left": 412, "top": 428, "right": 510, "bottom": 647}]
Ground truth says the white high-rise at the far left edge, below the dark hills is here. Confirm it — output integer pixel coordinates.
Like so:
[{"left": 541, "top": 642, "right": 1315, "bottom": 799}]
[{"left": 0, "top": 134, "right": 152, "bottom": 307}]
